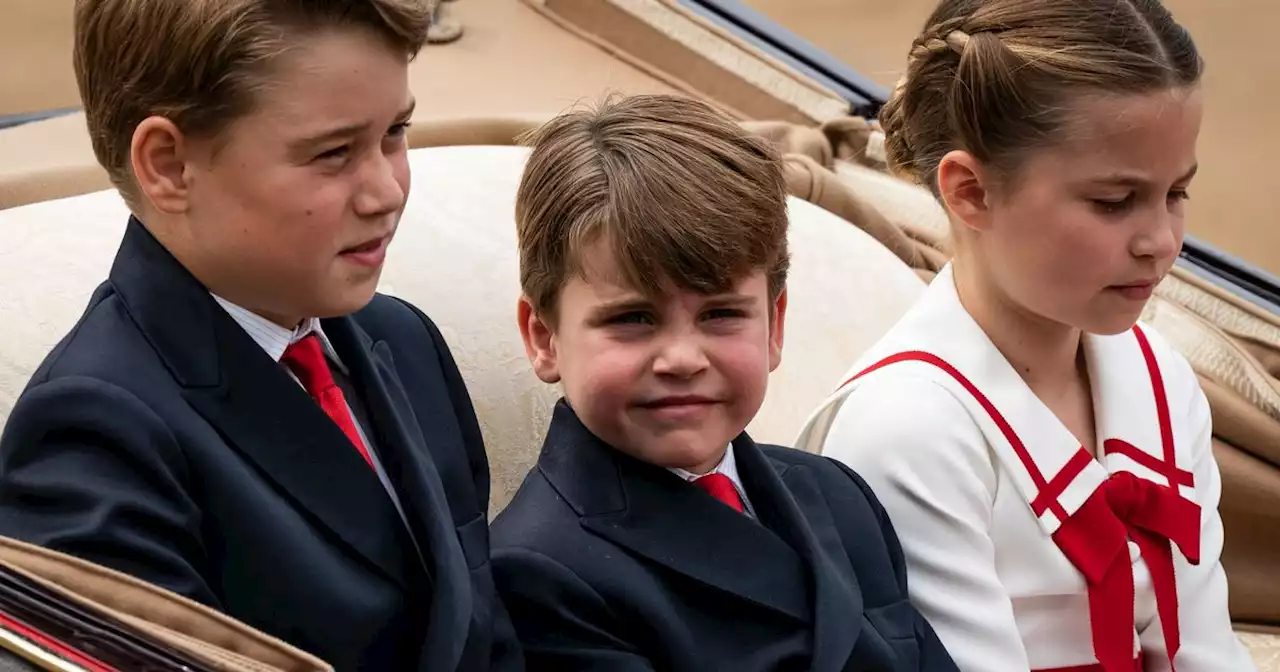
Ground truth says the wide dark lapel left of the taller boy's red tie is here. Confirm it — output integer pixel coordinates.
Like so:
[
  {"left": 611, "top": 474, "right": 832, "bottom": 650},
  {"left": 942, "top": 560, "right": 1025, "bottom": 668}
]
[{"left": 110, "top": 219, "right": 411, "bottom": 585}]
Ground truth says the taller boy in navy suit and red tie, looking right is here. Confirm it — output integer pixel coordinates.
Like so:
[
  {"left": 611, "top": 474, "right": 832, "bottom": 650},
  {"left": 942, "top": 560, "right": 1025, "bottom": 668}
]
[{"left": 0, "top": 0, "right": 522, "bottom": 672}]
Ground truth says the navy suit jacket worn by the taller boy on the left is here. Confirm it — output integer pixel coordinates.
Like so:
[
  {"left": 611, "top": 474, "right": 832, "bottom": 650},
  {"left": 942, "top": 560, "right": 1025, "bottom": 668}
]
[{"left": 0, "top": 220, "right": 524, "bottom": 672}]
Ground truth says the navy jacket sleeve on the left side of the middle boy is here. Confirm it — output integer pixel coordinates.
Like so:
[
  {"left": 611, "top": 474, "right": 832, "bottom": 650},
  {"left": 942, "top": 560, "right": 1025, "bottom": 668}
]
[{"left": 493, "top": 548, "right": 654, "bottom": 672}]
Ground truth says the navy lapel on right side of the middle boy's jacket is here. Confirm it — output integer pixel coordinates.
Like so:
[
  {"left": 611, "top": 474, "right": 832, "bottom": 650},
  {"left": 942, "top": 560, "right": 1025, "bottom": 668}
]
[{"left": 733, "top": 434, "right": 863, "bottom": 672}]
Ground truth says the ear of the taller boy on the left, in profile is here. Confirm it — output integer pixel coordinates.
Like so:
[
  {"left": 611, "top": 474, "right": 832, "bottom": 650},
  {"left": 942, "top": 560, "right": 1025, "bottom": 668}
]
[{"left": 129, "top": 116, "right": 191, "bottom": 214}]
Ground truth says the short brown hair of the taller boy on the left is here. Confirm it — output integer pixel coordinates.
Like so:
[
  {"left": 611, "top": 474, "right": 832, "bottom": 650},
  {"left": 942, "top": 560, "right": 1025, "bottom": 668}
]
[{"left": 73, "top": 0, "right": 435, "bottom": 202}]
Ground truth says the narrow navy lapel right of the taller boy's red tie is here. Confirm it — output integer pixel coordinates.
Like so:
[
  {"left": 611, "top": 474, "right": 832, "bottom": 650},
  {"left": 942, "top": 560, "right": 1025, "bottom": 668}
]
[{"left": 324, "top": 317, "right": 472, "bottom": 669}]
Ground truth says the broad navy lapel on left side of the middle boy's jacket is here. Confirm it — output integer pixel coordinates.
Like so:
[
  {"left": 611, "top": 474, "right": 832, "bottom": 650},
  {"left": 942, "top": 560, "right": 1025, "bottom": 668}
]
[{"left": 538, "top": 402, "right": 810, "bottom": 622}]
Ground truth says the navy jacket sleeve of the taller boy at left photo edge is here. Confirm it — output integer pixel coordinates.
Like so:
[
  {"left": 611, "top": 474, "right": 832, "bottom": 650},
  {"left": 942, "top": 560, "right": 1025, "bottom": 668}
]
[{"left": 0, "top": 378, "right": 212, "bottom": 608}]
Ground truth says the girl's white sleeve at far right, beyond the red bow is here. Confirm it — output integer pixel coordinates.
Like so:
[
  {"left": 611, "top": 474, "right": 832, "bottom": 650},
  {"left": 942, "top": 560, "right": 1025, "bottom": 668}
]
[{"left": 1140, "top": 355, "right": 1254, "bottom": 672}]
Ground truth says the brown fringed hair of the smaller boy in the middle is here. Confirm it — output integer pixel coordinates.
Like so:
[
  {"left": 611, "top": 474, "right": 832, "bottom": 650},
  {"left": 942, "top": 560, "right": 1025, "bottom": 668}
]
[{"left": 516, "top": 95, "right": 790, "bottom": 317}]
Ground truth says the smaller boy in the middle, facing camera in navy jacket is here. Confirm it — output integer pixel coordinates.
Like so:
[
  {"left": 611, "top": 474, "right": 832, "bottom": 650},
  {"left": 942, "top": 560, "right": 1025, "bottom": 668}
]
[{"left": 493, "top": 96, "right": 955, "bottom": 672}]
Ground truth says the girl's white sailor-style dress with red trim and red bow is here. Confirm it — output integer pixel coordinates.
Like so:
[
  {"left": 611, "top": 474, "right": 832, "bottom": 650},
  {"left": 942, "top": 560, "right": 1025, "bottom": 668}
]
[{"left": 797, "top": 266, "right": 1254, "bottom": 672}]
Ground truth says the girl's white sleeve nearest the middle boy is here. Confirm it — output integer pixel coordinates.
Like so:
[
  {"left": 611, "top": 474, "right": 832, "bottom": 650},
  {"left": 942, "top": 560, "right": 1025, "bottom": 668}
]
[{"left": 823, "top": 376, "right": 1030, "bottom": 672}]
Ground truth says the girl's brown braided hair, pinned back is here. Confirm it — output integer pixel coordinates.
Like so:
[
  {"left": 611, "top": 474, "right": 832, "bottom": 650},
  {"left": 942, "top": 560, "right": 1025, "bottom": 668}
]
[{"left": 879, "top": 0, "right": 1203, "bottom": 196}]
